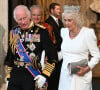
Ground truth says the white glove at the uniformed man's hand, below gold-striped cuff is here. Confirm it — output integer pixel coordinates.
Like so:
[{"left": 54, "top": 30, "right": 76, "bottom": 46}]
[{"left": 34, "top": 75, "right": 46, "bottom": 88}]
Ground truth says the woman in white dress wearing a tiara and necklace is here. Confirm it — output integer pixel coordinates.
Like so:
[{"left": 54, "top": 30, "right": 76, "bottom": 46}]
[{"left": 58, "top": 6, "right": 100, "bottom": 90}]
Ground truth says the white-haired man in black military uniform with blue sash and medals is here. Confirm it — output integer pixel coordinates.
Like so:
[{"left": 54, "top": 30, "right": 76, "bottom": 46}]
[{"left": 7, "top": 5, "right": 58, "bottom": 90}]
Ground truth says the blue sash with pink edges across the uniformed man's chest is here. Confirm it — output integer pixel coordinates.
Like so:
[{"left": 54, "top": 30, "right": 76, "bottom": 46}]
[{"left": 13, "top": 28, "right": 41, "bottom": 77}]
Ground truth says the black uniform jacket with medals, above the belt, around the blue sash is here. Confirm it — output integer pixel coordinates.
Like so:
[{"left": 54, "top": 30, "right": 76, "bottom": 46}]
[{"left": 7, "top": 22, "right": 58, "bottom": 78}]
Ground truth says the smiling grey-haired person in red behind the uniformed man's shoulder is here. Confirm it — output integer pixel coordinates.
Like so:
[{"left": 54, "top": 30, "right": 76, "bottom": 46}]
[{"left": 30, "top": 5, "right": 54, "bottom": 40}]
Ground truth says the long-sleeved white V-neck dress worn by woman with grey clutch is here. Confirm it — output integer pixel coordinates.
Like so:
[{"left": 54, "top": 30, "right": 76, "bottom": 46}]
[{"left": 58, "top": 27, "right": 100, "bottom": 90}]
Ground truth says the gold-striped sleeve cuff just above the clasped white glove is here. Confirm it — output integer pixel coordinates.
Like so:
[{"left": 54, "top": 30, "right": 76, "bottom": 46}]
[{"left": 42, "top": 63, "right": 55, "bottom": 77}]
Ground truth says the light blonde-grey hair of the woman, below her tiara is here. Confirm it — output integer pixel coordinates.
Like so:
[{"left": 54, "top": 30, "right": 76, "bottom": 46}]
[{"left": 62, "top": 12, "right": 85, "bottom": 28}]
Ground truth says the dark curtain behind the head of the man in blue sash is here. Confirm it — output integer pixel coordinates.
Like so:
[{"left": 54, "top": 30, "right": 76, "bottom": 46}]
[{"left": 8, "top": 0, "right": 36, "bottom": 30}]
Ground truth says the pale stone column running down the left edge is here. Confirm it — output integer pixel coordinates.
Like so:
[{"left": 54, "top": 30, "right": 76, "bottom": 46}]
[{"left": 0, "top": 0, "right": 8, "bottom": 90}]
